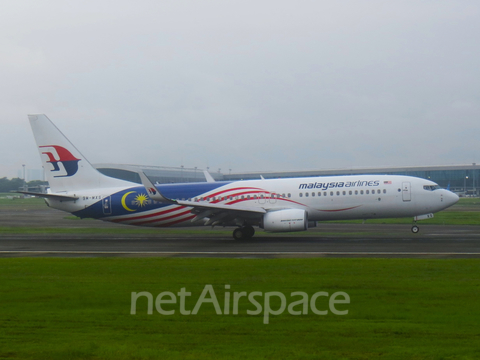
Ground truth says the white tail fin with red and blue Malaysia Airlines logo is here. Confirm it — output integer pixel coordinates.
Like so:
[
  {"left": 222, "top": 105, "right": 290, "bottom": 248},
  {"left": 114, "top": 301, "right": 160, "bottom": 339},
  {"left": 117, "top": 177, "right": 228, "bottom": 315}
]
[{"left": 28, "top": 115, "right": 136, "bottom": 193}]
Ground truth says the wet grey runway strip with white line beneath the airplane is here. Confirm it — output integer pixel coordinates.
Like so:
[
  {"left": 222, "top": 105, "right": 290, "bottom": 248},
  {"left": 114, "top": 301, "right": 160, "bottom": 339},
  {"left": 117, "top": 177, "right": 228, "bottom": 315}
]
[{"left": 0, "top": 224, "right": 480, "bottom": 258}]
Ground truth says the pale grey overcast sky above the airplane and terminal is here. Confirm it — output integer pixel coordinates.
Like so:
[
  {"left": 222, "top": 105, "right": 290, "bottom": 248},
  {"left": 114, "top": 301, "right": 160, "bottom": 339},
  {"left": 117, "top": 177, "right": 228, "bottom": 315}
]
[{"left": 0, "top": 0, "right": 480, "bottom": 177}]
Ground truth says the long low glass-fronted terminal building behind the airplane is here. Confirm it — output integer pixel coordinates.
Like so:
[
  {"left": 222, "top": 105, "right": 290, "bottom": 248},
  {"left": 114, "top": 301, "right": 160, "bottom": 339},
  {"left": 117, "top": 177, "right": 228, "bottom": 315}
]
[{"left": 94, "top": 163, "right": 480, "bottom": 196}]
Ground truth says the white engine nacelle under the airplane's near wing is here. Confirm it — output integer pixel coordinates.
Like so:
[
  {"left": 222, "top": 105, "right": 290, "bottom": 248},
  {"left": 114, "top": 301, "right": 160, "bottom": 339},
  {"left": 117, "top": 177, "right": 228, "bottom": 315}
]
[{"left": 263, "top": 209, "right": 308, "bottom": 232}]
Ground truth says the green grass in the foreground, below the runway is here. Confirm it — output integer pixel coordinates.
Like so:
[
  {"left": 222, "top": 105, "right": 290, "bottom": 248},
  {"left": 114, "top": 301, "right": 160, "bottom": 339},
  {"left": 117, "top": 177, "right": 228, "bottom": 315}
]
[{"left": 0, "top": 258, "right": 480, "bottom": 359}]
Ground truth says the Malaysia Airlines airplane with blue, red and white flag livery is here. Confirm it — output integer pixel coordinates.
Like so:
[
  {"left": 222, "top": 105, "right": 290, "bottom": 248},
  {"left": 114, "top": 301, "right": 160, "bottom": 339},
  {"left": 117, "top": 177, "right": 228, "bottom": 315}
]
[{"left": 18, "top": 114, "right": 459, "bottom": 240}]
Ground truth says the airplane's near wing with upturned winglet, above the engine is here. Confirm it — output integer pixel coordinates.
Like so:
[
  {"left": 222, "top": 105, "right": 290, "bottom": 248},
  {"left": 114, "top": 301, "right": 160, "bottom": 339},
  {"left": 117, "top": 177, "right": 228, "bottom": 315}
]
[{"left": 139, "top": 172, "right": 267, "bottom": 225}]
